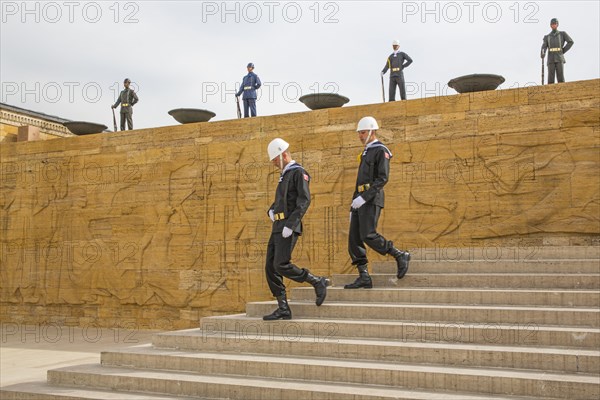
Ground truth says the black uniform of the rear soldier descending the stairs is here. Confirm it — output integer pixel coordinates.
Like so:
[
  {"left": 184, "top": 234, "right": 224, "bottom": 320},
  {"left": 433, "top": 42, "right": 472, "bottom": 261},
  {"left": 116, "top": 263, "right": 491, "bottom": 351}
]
[{"left": 348, "top": 141, "right": 393, "bottom": 265}]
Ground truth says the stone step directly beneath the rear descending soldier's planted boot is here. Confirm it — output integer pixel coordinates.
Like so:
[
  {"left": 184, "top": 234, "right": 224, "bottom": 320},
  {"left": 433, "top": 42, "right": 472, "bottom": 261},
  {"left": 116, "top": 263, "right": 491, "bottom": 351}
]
[{"left": 290, "top": 286, "right": 600, "bottom": 307}]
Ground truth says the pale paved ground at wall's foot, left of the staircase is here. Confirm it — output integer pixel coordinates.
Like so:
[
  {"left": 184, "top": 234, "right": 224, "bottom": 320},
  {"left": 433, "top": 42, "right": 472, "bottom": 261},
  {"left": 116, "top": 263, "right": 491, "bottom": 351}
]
[{"left": 0, "top": 322, "right": 155, "bottom": 387}]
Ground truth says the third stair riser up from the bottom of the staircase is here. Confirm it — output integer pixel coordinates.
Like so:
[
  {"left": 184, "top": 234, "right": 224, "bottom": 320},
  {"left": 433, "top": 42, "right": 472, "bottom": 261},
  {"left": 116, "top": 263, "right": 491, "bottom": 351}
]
[{"left": 102, "top": 353, "right": 599, "bottom": 399}]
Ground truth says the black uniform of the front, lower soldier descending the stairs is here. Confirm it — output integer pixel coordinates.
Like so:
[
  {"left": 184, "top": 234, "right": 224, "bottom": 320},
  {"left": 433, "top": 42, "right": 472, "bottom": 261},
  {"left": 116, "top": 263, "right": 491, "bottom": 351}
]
[{"left": 265, "top": 162, "right": 310, "bottom": 297}]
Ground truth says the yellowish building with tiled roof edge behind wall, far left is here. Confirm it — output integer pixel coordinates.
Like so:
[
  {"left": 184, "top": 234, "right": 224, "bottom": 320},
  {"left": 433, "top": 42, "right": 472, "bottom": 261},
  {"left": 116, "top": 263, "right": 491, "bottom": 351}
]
[{"left": 0, "top": 103, "right": 75, "bottom": 142}]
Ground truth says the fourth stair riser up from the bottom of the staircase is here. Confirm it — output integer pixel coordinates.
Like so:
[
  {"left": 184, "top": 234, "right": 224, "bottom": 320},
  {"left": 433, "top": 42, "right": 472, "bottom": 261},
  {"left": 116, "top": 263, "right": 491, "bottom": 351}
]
[{"left": 152, "top": 332, "right": 600, "bottom": 373}]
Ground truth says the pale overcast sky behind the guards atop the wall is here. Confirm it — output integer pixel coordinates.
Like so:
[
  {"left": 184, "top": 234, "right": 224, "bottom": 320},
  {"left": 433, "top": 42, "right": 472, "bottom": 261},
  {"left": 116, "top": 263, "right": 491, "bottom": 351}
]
[{"left": 0, "top": 0, "right": 600, "bottom": 129}]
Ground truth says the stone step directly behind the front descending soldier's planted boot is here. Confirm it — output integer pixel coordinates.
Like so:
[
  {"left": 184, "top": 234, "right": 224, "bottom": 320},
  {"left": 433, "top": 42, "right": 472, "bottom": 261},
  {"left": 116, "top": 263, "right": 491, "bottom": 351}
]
[{"left": 246, "top": 300, "right": 600, "bottom": 328}]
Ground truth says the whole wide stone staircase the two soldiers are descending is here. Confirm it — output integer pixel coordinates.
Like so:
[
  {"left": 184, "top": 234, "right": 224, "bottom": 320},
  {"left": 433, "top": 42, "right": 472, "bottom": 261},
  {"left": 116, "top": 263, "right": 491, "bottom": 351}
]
[{"left": 0, "top": 247, "right": 600, "bottom": 400}]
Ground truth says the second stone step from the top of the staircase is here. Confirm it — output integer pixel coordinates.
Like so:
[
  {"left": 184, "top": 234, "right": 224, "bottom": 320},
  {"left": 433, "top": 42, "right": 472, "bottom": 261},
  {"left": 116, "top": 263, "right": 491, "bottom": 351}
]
[{"left": 370, "top": 260, "right": 600, "bottom": 274}]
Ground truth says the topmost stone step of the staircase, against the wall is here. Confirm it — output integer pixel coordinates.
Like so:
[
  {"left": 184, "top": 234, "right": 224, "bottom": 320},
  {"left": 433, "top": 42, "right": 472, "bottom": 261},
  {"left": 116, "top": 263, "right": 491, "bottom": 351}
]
[{"left": 400, "top": 244, "right": 600, "bottom": 262}]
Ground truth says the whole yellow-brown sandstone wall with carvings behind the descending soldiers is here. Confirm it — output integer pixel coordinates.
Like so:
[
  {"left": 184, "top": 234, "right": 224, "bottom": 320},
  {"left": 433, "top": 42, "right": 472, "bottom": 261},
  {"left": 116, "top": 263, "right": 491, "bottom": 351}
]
[{"left": 0, "top": 80, "right": 600, "bottom": 329}]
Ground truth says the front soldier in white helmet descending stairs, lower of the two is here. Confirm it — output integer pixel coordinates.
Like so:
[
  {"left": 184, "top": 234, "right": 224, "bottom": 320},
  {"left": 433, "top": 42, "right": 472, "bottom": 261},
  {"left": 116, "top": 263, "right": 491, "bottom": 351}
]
[{"left": 263, "top": 138, "right": 330, "bottom": 321}]
